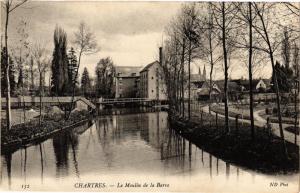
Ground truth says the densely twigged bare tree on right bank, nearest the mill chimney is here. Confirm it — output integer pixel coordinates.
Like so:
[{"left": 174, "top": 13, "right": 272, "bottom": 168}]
[{"left": 163, "top": 3, "right": 200, "bottom": 117}]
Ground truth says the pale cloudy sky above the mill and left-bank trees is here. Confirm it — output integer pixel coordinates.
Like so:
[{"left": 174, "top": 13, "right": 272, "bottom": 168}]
[{"left": 5, "top": 1, "right": 181, "bottom": 75}]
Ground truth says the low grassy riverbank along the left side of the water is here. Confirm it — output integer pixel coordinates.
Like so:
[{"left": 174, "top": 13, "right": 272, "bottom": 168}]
[{"left": 1, "top": 111, "right": 93, "bottom": 154}]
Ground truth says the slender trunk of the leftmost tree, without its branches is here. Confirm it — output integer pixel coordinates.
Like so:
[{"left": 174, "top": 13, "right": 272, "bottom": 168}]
[{"left": 5, "top": 5, "right": 11, "bottom": 130}]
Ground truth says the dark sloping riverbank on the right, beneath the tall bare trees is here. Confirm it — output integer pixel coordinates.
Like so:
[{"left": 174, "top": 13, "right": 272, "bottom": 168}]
[{"left": 170, "top": 113, "right": 299, "bottom": 174}]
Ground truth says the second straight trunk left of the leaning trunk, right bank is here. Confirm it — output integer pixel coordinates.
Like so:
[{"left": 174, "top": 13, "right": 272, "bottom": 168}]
[{"left": 222, "top": 2, "right": 229, "bottom": 133}]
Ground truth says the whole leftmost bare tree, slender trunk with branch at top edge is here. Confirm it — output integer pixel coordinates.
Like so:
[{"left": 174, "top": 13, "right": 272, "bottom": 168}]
[{"left": 1, "top": 0, "right": 27, "bottom": 130}]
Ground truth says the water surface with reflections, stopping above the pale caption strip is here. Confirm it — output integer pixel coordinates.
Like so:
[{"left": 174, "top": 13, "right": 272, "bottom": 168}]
[{"left": 1, "top": 112, "right": 298, "bottom": 191}]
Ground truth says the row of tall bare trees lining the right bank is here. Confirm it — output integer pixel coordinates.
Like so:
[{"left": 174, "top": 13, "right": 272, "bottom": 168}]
[{"left": 161, "top": 2, "right": 299, "bottom": 156}]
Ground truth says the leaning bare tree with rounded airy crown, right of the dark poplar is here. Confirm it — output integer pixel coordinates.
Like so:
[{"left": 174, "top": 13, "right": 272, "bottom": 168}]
[{"left": 67, "top": 22, "right": 98, "bottom": 119}]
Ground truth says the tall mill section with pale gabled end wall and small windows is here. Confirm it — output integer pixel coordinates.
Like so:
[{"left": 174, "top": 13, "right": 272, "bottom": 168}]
[{"left": 140, "top": 61, "right": 167, "bottom": 100}]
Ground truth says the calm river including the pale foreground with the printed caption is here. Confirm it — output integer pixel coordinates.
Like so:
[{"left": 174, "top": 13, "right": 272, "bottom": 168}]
[{"left": 0, "top": 112, "right": 299, "bottom": 192}]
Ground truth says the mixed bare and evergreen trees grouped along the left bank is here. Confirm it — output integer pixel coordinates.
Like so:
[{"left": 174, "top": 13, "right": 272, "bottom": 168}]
[{"left": 1, "top": 0, "right": 103, "bottom": 129}]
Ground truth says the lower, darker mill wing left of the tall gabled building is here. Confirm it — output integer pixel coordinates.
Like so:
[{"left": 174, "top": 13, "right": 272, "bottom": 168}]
[{"left": 114, "top": 66, "right": 141, "bottom": 98}]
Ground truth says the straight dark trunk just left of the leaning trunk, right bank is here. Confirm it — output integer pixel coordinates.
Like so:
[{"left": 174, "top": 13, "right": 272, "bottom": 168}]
[{"left": 248, "top": 2, "right": 255, "bottom": 140}]
